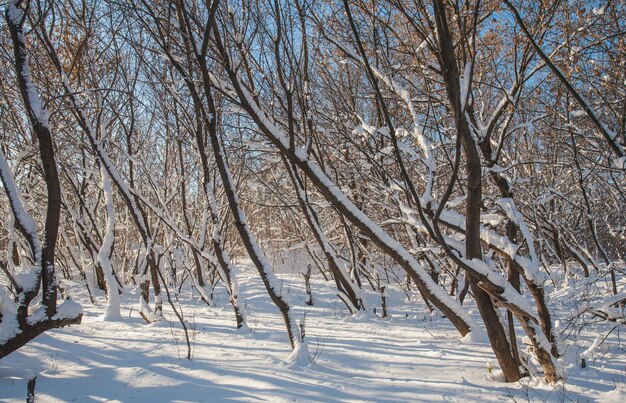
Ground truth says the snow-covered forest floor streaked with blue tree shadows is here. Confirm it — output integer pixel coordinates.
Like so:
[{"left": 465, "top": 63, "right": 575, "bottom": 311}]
[{"left": 0, "top": 265, "right": 626, "bottom": 402}]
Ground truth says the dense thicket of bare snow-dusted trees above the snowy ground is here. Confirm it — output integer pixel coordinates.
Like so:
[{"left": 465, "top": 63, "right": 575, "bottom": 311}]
[{"left": 0, "top": 0, "right": 626, "bottom": 382}]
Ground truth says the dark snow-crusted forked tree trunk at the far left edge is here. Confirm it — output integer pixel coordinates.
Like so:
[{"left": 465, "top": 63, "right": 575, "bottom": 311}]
[{"left": 0, "top": 2, "right": 82, "bottom": 358}]
